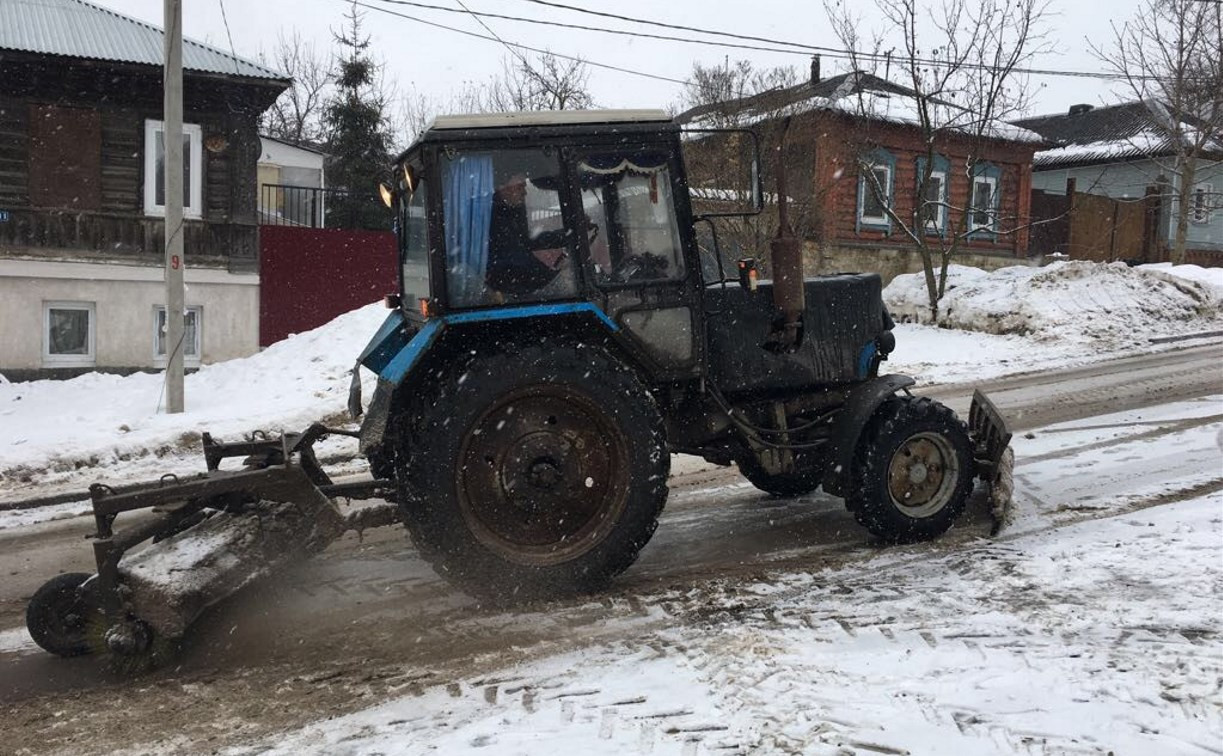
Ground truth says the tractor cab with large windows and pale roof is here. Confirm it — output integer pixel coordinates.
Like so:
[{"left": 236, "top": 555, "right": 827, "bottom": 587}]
[{"left": 384, "top": 110, "right": 701, "bottom": 378}]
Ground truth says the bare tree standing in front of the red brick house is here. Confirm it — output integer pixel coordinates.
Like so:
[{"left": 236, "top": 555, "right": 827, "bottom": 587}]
[{"left": 824, "top": 0, "right": 1047, "bottom": 319}]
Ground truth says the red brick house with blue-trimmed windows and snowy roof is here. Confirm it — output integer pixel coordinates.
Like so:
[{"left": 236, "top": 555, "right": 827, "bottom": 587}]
[{"left": 678, "top": 71, "right": 1042, "bottom": 281}]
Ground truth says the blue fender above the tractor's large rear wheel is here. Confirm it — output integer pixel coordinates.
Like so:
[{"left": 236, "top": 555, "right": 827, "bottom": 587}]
[{"left": 349, "top": 302, "right": 620, "bottom": 453}]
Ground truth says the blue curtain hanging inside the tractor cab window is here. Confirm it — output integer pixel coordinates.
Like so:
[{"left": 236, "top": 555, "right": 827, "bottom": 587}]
[{"left": 442, "top": 154, "right": 494, "bottom": 306}]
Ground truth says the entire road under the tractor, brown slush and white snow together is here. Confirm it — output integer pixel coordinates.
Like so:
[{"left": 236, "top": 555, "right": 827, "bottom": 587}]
[{"left": 0, "top": 362, "right": 1223, "bottom": 754}]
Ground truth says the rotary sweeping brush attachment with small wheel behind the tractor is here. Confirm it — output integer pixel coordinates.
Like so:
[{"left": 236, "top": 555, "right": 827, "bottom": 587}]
[{"left": 26, "top": 424, "right": 397, "bottom": 659}]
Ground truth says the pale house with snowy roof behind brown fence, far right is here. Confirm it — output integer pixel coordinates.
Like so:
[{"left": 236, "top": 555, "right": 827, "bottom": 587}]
[{"left": 1015, "top": 100, "right": 1223, "bottom": 265}]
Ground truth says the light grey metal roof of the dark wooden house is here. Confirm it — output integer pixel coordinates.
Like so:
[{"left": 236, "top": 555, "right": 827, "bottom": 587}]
[{"left": 0, "top": 0, "right": 289, "bottom": 81}]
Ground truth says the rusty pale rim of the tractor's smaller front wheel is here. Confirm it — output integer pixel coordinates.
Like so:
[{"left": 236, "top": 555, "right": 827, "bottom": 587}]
[{"left": 888, "top": 433, "right": 960, "bottom": 519}]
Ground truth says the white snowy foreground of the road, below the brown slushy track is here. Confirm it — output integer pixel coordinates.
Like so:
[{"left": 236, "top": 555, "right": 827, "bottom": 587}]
[{"left": 243, "top": 494, "right": 1223, "bottom": 756}]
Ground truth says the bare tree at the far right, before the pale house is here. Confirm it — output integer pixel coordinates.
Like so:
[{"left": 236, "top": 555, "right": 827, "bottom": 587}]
[{"left": 1092, "top": 0, "right": 1223, "bottom": 263}]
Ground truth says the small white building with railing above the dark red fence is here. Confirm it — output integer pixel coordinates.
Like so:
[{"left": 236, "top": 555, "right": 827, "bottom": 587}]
[{"left": 259, "top": 135, "right": 327, "bottom": 229}]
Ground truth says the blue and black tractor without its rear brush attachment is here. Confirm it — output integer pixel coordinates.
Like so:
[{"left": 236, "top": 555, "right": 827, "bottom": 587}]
[{"left": 350, "top": 110, "right": 1009, "bottom": 596}]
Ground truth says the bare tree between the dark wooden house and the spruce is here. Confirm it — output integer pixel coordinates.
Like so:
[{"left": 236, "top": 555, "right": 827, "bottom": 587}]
[{"left": 260, "top": 32, "right": 335, "bottom": 144}]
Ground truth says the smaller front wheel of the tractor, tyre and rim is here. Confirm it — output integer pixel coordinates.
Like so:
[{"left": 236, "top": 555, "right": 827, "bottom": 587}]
[{"left": 845, "top": 396, "right": 972, "bottom": 543}]
